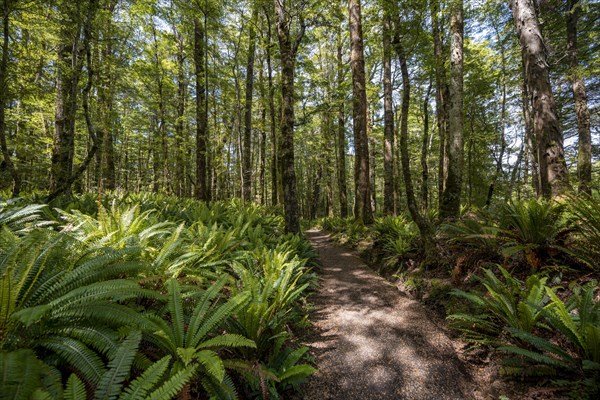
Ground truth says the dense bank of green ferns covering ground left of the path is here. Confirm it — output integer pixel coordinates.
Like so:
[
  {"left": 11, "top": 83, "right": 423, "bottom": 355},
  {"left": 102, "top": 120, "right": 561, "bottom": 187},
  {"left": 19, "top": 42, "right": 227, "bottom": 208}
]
[{"left": 0, "top": 194, "right": 314, "bottom": 399}]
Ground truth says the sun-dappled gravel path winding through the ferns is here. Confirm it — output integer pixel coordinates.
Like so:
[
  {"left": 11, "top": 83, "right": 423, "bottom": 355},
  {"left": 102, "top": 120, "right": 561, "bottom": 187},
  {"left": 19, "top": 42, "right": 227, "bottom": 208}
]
[{"left": 304, "top": 231, "right": 475, "bottom": 400}]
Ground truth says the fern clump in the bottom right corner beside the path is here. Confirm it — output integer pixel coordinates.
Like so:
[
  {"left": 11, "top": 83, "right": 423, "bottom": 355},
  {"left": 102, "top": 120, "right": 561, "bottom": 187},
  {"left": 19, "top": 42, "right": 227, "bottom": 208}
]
[{"left": 448, "top": 267, "right": 600, "bottom": 398}]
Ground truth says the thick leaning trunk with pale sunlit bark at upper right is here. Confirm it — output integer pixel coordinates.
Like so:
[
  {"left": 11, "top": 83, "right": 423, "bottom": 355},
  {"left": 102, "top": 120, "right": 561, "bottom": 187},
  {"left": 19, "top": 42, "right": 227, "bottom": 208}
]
[{"left": 509, "top": 0, "right": 570, "bottom": 197}]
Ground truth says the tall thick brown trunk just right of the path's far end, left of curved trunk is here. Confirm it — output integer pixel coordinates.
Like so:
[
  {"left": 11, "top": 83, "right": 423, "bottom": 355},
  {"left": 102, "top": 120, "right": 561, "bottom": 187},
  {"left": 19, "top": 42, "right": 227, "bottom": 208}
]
[{"left": 348, "top": 0, "right": 373, "bottom": 224}]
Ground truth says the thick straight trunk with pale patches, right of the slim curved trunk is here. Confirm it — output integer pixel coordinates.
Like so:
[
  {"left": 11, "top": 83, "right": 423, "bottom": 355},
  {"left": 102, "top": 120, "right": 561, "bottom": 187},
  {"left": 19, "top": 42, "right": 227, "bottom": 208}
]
[{"left": 440, "top": 0, "right": 464, "bottom": 219}]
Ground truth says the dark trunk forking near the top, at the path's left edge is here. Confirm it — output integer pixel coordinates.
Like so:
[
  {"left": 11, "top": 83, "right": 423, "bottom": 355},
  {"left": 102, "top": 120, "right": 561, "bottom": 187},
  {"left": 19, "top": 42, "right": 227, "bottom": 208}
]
[{"left": 274, "top": 0, "right": 306, "bottom": 233}]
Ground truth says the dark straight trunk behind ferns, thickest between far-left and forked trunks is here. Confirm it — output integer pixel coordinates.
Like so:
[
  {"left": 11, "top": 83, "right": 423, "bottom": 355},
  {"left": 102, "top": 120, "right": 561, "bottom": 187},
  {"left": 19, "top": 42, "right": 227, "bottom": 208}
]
[{"left": 194, "top": 18, "right": 209, "bottom": 201}]
